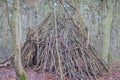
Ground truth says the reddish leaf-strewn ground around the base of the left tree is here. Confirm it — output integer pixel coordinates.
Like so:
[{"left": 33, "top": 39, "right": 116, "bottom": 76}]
[{"left": 0, "top": 67, "right": 70, "bottom": 80}]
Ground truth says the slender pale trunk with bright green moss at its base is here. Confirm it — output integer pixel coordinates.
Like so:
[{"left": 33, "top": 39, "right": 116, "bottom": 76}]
[{"left": 11, "top": 0, "right": 27, "bottom": 80}]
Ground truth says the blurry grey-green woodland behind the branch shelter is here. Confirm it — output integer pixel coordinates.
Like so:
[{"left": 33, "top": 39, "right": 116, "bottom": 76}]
[{"left": 0, "top": 0, "right": 120, "bottom": 61}]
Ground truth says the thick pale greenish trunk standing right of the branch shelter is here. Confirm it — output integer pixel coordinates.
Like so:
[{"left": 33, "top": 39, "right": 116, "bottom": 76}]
[{"left": 101, "top": 0, "right": 113, "bottom": 63}]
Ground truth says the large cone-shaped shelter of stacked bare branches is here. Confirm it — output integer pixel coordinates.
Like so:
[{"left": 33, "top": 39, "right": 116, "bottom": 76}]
[{"left": 22, "top": 11, "right": 108, "bottom": 80}]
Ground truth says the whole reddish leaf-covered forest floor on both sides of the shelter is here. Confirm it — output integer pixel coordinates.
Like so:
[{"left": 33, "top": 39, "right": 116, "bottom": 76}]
[{"left": 0, "top": 62, "right": 120, "bottom": 80}]
